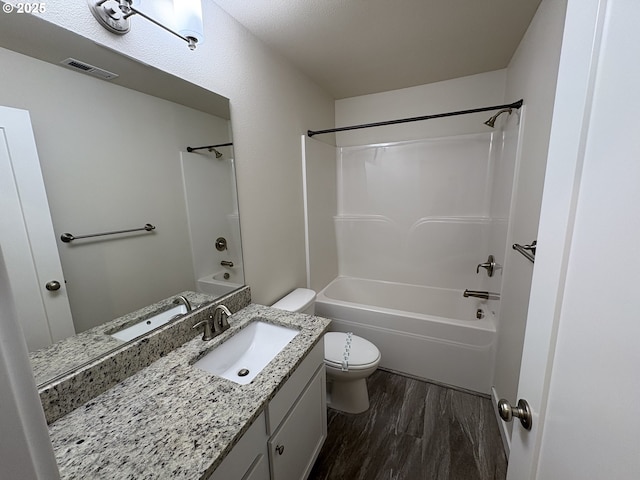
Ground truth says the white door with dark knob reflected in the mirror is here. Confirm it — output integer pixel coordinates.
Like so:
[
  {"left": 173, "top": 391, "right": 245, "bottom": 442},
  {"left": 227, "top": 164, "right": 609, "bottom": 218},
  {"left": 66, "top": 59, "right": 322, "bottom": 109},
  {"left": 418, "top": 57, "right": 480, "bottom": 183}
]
[{"left": 0, "top": 107, "right": 75, "bottom": 350}]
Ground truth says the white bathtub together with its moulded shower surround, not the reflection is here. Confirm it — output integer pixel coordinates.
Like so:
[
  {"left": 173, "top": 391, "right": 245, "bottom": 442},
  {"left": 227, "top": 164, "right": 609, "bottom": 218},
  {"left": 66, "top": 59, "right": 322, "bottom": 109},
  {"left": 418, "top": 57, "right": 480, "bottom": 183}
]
[{"left": 304, "top": 108, "right": 519, "bottom": 394}]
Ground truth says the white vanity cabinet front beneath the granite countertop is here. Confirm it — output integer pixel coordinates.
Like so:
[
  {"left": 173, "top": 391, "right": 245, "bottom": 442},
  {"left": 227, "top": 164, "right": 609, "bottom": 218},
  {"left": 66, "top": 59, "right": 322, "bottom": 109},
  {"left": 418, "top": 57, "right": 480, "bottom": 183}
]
[{"left": 208, "top": 339, "right": 327, "bottom": 480}]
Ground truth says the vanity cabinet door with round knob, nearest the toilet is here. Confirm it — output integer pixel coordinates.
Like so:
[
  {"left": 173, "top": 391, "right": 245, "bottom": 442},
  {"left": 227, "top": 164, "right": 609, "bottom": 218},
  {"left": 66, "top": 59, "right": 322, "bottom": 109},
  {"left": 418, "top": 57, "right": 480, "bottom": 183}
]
[{"left": 269, "top": 365, "right": 327, "bottom": 480}]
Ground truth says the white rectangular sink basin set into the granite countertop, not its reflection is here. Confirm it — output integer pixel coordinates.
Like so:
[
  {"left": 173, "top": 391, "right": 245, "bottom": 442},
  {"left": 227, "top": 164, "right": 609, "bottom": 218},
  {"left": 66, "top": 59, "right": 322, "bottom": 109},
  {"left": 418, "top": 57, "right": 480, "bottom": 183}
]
[{"left": 194, "top": 320, "right": 299, "bottom": 385}]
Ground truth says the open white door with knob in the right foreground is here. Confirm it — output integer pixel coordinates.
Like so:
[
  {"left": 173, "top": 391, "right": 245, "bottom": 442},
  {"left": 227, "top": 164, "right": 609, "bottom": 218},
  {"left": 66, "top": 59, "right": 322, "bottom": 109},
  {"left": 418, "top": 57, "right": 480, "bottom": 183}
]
[{"left": 507, "top": 0, "right": 640, "bottom": 474}]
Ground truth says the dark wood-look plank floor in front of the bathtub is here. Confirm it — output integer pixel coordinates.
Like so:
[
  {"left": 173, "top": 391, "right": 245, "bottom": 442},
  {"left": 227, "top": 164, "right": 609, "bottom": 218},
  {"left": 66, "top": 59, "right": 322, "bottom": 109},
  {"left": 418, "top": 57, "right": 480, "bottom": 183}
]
[{"left": 309, "top": 370, "right": 507, "bottom": 480}]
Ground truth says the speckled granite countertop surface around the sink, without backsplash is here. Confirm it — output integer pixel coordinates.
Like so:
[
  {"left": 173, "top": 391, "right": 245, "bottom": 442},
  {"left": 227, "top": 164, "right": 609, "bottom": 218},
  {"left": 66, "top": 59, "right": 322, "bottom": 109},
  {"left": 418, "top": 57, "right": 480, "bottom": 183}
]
[{"left": 49, "top": 304, "right": 330, "bottom": 480}]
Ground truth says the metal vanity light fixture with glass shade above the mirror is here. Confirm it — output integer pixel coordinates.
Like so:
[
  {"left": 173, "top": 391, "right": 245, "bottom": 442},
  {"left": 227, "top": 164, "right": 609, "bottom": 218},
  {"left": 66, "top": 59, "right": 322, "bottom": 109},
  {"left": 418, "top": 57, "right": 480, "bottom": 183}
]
[{"left": 87, "top": 0, "right": 204, "bottom": 50}]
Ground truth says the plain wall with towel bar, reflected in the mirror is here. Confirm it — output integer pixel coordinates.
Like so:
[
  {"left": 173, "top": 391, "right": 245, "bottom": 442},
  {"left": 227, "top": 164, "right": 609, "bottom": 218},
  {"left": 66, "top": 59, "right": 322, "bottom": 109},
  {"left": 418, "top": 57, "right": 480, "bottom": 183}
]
[{"left": 0, "top": 49, "right": 231, "bottom": 332}]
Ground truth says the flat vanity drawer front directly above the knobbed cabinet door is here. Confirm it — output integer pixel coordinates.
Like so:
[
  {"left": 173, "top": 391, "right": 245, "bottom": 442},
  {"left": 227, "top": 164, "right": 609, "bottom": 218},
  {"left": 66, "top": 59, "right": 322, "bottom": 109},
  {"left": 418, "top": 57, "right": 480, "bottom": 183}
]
[{"left": 267, "top": 338, "right": 325, "bottom": 434}]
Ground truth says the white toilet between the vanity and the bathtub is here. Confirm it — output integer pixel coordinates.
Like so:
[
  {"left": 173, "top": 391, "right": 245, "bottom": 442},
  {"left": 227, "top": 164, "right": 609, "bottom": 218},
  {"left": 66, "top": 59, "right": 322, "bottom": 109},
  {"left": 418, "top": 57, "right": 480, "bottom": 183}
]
[{"left": 272, "top": 288, "right": 380, "bottom": 413}]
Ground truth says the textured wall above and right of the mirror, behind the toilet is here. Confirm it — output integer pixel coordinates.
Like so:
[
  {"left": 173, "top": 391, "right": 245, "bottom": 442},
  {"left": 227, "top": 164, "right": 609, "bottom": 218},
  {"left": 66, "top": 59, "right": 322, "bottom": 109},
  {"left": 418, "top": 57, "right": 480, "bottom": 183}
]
[{"left": 30, "top": 0, "right": 334, "bottom": 304}]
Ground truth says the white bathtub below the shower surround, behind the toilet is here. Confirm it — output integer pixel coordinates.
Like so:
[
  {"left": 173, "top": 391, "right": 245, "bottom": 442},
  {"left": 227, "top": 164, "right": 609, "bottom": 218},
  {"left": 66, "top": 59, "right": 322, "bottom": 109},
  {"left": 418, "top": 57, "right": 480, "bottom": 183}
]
[{"left": 316, "top": 277, "right": 496, "bottom": 394}]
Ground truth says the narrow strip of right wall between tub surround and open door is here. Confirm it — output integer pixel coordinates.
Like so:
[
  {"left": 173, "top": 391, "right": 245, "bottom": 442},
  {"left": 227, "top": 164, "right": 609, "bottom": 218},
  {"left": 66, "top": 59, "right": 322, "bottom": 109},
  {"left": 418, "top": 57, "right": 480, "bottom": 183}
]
[{"left": 494, "top": 0, "right": 566, "bottom": 436}]
